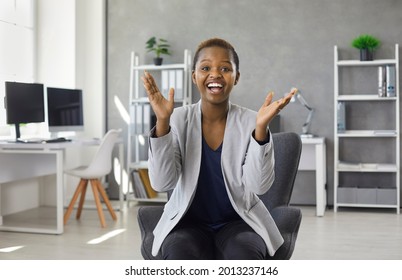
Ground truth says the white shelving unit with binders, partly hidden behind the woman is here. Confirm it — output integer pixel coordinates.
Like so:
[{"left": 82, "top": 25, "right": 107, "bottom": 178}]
[{"left": 127, "top": 50, "right": 192, "bottom": 202}]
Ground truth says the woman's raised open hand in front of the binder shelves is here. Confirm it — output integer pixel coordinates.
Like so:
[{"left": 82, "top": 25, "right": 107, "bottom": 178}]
[{"left": 141, "top": 71, "right": 174, "bottom": 137}]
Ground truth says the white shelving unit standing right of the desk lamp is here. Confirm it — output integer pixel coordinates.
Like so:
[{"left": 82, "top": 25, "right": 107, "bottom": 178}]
[{"left": 334, "top": 44, "right": 400, "bottom": 214}]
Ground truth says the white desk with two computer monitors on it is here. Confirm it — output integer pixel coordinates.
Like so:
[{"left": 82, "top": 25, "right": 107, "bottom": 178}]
[{"left": 0, "top": 140, "right": 123, "bottom": 234}]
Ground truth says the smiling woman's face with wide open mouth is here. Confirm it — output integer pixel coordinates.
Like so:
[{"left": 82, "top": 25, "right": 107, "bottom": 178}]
[{"left": 192, "top": 47, "right": 240, "bottom": 104}]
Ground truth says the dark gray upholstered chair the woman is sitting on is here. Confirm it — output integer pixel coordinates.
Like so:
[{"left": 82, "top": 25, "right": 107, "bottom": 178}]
[{"left": 137, "top": 132, "right": 302, "bottom": 260}]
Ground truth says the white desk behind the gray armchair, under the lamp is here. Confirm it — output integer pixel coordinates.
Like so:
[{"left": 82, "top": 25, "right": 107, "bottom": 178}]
[{"left": 299, "top": 137, "right": 327, "bottom": 216}]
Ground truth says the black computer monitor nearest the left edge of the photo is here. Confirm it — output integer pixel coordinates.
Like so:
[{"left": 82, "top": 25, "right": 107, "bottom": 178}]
[{"left": 4, "top": 81, "right": 45, "bottom": 141}]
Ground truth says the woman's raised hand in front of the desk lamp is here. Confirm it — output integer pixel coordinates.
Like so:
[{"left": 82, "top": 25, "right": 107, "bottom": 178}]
[{"left": 255, "top": 88, "right": 297, "bottom": 141}]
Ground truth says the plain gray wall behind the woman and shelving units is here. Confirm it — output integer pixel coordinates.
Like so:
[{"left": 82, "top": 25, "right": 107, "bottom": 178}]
[{"left": 107, "top": 0, "right": 402, "bottom": 204}]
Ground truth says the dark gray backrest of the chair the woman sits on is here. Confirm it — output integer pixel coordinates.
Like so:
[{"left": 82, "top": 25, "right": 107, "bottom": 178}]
[{"left": 260, "top": 132, "right": 302, "bottom": 210}]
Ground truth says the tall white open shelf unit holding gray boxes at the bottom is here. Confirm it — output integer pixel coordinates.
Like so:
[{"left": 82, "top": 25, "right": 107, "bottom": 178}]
[{"left": 334, "top": 44, "right": 400, "bottom": 214}]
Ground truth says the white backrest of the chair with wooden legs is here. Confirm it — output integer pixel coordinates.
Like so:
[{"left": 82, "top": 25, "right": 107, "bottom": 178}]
[{"left": 87, "top": 129, "right": 121, "bottom": 176}]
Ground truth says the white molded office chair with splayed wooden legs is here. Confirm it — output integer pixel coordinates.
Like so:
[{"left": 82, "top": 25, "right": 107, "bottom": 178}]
[{"left": 64, "top": 129, "right": 121, "bottom": 227}]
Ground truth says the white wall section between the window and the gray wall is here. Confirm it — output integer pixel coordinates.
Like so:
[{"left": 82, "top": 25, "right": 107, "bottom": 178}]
[{"left": 37, "top": 0, "right": 105, "bottom": 201}]
